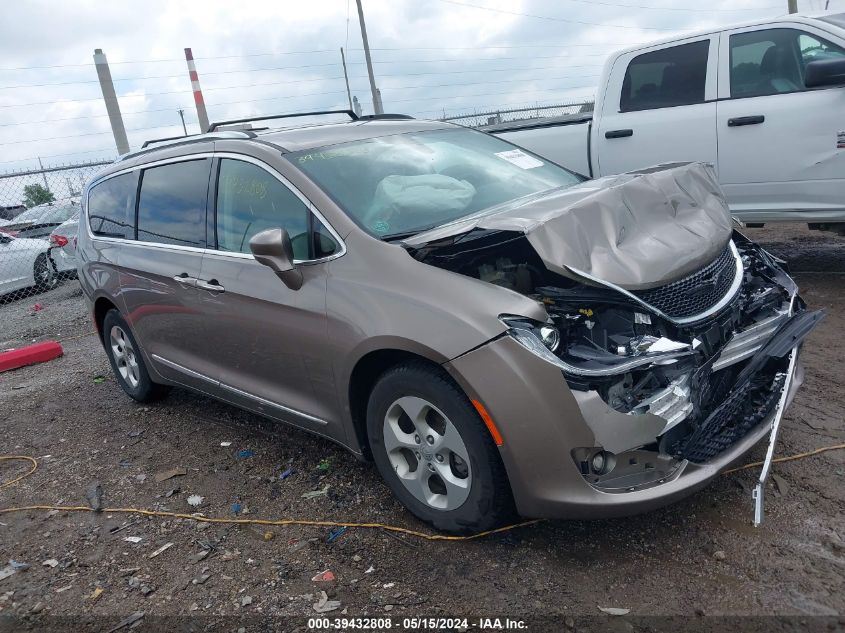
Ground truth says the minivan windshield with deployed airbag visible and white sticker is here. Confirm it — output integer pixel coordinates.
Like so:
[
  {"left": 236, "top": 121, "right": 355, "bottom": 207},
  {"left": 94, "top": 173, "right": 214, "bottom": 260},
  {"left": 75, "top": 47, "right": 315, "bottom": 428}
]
[{"left": 287, "top": 129, "right": 583, "bottom": 239}]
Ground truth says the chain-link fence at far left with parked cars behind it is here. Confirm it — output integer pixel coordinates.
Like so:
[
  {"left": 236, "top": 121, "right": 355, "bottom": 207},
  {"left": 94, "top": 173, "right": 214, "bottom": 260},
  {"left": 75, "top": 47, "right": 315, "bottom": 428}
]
[{"left": 0, "top": 161, "right": 110, "bottom": 351}]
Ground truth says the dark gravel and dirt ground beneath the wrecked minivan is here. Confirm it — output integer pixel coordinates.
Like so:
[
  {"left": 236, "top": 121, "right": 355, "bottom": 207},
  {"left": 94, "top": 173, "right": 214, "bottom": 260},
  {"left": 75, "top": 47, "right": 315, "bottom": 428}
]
[{"left": 0, "top": 225, "right": 845, "bottom": 631}]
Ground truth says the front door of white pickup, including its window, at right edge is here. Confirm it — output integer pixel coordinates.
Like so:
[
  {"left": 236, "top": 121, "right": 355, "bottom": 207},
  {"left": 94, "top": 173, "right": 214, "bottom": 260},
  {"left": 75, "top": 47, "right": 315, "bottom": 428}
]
[{"left": 717, "top": 22, "right": 845, "bottom": 222}]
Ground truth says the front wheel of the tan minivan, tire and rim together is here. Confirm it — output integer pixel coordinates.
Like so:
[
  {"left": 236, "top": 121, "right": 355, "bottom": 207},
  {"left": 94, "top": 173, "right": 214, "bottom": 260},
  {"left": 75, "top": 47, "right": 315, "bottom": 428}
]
[{"left": 367, "top": 362, "right": 514, "bottom": 533}]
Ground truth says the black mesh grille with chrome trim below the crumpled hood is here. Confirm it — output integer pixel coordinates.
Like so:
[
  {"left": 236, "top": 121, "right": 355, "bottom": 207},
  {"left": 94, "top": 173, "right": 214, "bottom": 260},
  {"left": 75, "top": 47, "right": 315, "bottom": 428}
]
[{"left": 634, "top": 244, "right": 737, "bottom": 319}]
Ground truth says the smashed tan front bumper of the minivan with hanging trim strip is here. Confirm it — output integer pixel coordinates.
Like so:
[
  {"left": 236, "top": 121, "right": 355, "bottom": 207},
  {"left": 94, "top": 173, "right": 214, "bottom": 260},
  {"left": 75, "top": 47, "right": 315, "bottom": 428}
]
[{"left": 447, "top": 241, "right": 823, "bottom": 525}]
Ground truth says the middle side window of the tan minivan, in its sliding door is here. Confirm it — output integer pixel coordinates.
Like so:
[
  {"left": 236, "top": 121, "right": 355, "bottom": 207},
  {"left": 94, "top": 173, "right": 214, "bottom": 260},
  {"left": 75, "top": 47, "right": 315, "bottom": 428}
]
[{"left": 138, "top": 159, "right": 211, "bottom": 248}]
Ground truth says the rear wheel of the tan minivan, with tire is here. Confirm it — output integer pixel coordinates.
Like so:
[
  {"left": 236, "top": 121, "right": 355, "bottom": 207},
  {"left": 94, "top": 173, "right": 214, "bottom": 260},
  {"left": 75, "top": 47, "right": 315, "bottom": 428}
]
[{"left": 103, "top": 310, "right": 170, "bottom": 402}]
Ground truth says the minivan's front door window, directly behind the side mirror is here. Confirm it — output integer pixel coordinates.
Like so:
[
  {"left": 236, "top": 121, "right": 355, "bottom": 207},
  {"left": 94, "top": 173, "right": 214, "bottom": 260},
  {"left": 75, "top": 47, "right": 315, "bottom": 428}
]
[{"left": 217, "top": 158, "right": 311, "bottom": 260}]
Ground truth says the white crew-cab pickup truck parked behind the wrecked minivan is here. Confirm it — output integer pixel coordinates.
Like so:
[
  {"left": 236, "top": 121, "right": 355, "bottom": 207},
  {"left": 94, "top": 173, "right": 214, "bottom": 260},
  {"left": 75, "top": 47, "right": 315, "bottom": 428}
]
[{"left": 488, "top": 13, "right": 845, "bottom": 230}]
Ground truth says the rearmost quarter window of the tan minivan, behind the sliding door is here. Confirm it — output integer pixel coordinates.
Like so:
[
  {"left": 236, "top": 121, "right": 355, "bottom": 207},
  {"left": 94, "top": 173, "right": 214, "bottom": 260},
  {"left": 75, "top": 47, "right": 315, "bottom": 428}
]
[{"left": 88, "top": 173, "right": 138, "bottom": 239}]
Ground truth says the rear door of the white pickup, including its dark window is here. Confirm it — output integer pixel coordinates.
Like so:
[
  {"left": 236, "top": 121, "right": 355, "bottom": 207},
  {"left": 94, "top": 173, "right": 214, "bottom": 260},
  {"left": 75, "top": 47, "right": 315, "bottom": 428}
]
[{"left": 593, "top": 34, "right": 719, "bottom": 176}]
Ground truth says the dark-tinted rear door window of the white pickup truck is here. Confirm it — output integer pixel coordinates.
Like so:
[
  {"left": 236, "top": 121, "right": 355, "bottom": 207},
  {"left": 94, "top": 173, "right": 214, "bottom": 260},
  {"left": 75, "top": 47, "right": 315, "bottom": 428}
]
[{"left": 619, "top": 40, "right": 710, "bottom": 112}]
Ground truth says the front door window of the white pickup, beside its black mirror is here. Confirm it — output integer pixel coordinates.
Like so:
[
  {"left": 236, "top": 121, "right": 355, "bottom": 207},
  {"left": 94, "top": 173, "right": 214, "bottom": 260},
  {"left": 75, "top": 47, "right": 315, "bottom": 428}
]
[{"left": 730, "top": 29, "right": 845, "bottom": 97}]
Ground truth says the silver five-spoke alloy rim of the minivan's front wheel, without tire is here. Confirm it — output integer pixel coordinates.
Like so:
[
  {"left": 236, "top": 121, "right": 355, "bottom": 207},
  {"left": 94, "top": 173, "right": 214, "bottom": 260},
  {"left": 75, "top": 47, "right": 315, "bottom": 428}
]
[{"left": 384, "top": 396, "right": 472, "bottom": 511}]
